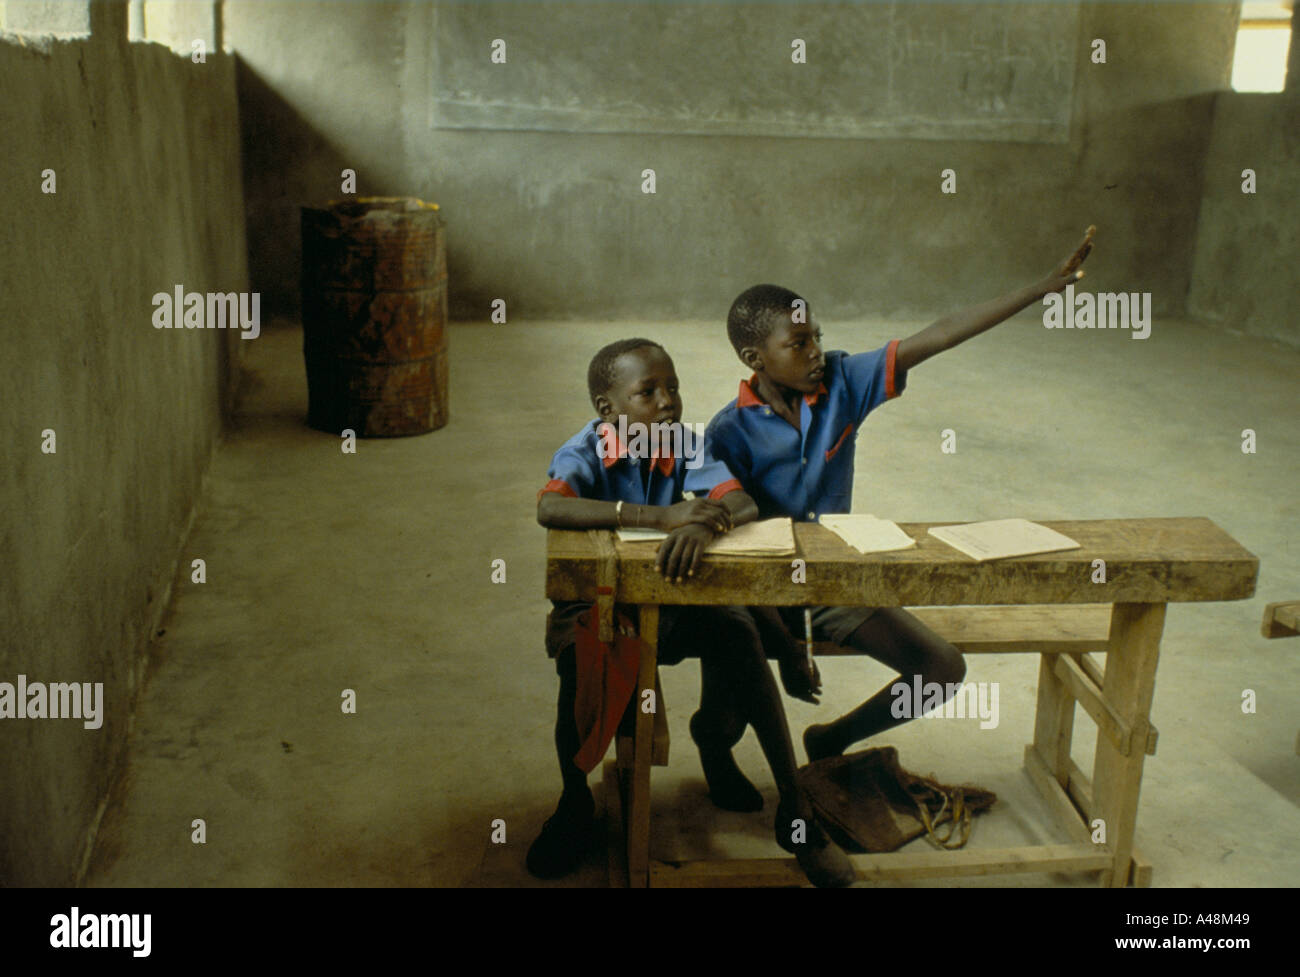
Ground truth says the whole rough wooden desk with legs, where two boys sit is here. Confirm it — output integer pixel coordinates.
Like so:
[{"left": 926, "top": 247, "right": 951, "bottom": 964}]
[{"left": 546, "top": 518, "right": 1258, "bottom": 886}]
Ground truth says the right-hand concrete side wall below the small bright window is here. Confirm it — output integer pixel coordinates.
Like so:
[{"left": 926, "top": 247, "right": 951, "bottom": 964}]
[{"left": 1187, "top": 90, "right": 1300, "bottom": 346}]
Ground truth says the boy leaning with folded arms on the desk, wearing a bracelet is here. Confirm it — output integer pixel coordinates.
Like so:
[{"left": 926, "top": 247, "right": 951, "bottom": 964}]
[{"left": 528, "top": 339, "right": 854, "bottom": 885}]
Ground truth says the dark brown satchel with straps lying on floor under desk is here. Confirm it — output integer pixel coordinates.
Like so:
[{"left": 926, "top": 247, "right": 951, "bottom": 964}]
[{"left": 798, "top": 746, "right": 997, "bottom": 854}]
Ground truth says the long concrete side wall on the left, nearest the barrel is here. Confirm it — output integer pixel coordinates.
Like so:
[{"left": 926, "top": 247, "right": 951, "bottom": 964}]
[{"left": 0, "top": 19, "right": 246, "bottom": 885}]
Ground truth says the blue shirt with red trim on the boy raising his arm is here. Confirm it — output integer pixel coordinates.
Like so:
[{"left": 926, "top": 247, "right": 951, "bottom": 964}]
[{"left": 705, "top": 339, "right": 907, "bottom": 522}]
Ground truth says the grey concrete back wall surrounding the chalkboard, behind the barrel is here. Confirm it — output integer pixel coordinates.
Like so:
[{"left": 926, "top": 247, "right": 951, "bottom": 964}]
[{"left": 224, "top": 0, "right": 1238, "bottom": 326}]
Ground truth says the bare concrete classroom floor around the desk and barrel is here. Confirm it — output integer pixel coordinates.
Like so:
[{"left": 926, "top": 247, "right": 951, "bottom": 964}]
[{"left": 90, "top": 311, "right": 1300, "bottom": 886}]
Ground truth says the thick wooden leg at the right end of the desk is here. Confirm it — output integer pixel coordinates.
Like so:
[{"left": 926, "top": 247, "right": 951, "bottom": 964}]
[{"left": 1089, "top": 604, "right": 1165, "bottom": 889}]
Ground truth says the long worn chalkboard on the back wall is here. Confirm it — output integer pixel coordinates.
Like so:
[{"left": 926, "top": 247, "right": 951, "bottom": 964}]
[{"left": 430, "top": 3, "right": 1079, "bottom": 142}]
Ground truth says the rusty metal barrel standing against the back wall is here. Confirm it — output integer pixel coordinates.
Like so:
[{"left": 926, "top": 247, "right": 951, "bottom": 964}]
[{"left": 302, "top": 197, "right": 447, "bottom": 438}]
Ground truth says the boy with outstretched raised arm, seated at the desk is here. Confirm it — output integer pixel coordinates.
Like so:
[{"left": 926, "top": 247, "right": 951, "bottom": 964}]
[{"left": 705, "top": 227, "right": 1096, "bottom": 760}]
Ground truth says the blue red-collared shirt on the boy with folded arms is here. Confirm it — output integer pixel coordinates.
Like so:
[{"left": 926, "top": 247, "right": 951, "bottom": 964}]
[{"left": 537, "top": 420, "right": 741, "bottom": 505}]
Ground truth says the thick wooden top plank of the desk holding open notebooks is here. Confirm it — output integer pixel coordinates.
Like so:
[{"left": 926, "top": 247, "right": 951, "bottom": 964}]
[{"left": 546, "top": 518, "right": 1260, "bottom": 607}]
